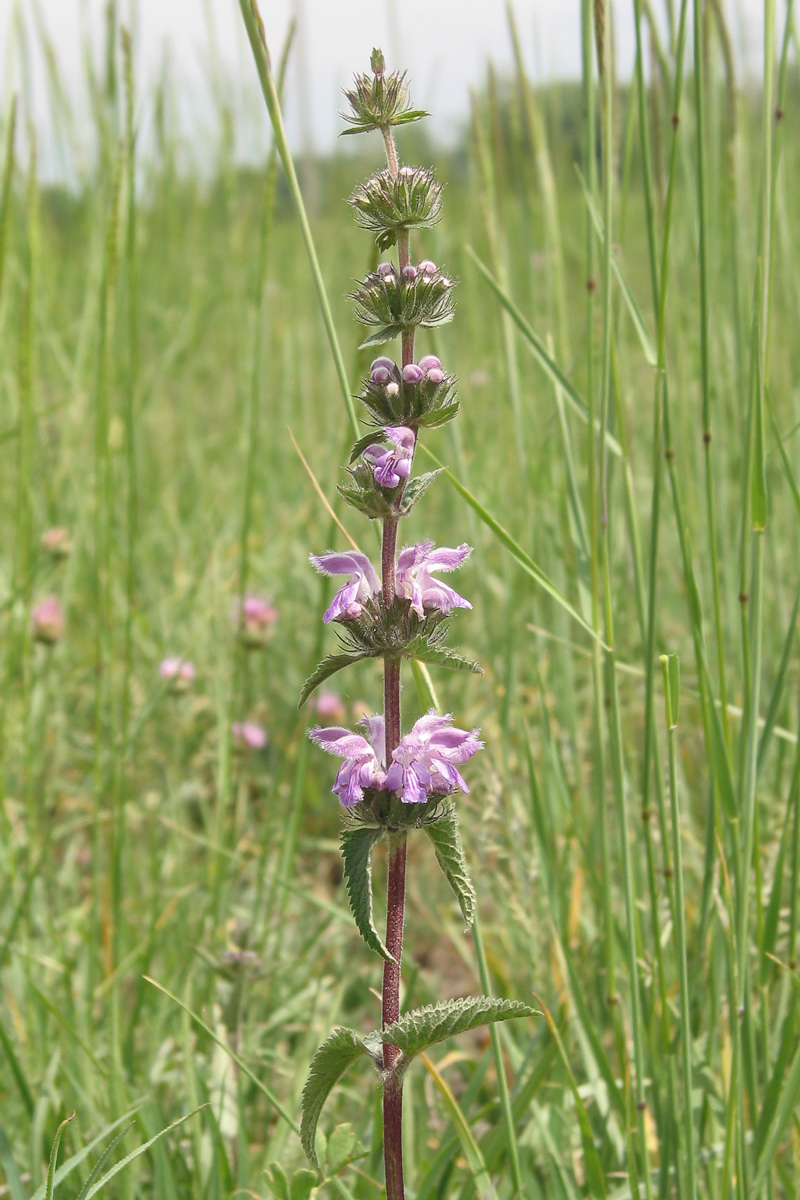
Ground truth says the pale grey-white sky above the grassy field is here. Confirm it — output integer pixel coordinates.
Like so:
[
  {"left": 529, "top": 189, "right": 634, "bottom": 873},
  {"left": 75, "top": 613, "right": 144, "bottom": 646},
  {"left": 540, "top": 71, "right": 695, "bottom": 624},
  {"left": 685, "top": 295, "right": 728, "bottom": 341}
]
[{"left": 0, "top": 0, "right": 786, "bottom": 173}]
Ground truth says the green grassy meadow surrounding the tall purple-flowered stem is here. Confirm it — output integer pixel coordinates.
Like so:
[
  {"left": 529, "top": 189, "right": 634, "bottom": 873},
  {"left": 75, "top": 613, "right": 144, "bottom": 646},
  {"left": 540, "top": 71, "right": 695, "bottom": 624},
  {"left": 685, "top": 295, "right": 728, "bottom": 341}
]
[{"left": 0, "top": 0, "right": 800, "bottom": 1200}]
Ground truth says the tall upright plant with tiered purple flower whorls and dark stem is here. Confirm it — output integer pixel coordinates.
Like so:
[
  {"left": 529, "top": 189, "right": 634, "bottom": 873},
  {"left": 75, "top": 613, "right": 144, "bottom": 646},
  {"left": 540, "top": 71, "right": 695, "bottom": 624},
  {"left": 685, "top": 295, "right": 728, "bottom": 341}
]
[{"left": 291, "top": 50, "right": 531, "bottom": 1200}]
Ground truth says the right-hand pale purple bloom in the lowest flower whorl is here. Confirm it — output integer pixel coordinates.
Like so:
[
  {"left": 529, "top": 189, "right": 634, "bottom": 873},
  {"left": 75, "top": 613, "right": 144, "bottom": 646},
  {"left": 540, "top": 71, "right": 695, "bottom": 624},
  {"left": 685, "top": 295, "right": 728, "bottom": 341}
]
[{"left": 384, "top": 709, "right": 483, "bottom": 804}]
